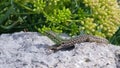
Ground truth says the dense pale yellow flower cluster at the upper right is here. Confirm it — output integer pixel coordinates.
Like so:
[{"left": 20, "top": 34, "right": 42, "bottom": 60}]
[{"left": 84, "top": 0, "right": 120, "bottom": 37}]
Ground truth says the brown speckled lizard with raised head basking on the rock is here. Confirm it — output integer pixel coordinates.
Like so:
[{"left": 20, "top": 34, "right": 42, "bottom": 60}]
[{"left": 43, "top": 32, "right": 109, "bottom": 52}]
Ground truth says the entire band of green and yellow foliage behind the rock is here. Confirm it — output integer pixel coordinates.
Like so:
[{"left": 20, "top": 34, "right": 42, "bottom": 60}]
[{"left": 0, "top": 0, "right": 120, "bottom": 44}]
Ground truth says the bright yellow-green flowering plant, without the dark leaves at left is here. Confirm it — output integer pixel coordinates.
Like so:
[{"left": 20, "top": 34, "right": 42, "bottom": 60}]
[{"left": 34, "top": 0, "right": 120, "bottom": 38}]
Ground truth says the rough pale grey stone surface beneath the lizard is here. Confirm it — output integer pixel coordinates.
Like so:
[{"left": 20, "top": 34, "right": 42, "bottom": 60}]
[{"left": 0, "top": 32, "right": 120, "bottom": 68}]
